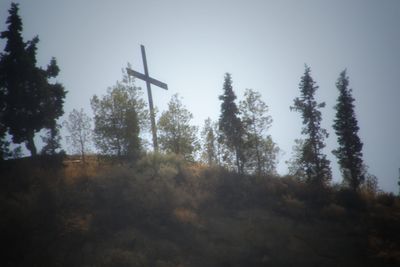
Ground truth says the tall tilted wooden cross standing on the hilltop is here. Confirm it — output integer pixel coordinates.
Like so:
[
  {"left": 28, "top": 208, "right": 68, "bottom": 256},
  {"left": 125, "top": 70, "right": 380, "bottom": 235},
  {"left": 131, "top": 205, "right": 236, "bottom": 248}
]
[{"left": 126, "top": 45, "right": 168, "bottom": 152}]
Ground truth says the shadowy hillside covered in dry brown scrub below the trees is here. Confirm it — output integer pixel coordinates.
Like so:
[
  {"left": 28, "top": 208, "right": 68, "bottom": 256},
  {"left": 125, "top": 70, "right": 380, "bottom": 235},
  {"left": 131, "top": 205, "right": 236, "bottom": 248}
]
[{"left": 0, "top": 155, "right": 400, "bottom": 267}]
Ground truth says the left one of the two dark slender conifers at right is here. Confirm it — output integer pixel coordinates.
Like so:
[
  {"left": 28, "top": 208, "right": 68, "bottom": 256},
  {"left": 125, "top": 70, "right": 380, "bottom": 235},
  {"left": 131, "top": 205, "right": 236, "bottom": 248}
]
[{"left": 290, "top": 66, "right": 332, "bottom": 185}]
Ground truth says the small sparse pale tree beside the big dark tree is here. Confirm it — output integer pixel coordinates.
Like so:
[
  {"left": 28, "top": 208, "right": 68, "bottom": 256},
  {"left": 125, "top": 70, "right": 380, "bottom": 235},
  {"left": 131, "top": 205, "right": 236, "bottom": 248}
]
[{"left": 64, "top": 109, "right": 92, "bottom": 162}]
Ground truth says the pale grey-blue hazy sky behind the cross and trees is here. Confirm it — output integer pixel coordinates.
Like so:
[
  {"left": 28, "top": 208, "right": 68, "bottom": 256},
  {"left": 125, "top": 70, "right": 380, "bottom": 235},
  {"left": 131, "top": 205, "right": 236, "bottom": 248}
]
[{"left": 0, "top": 0, "right": 400, "bottom": 193}]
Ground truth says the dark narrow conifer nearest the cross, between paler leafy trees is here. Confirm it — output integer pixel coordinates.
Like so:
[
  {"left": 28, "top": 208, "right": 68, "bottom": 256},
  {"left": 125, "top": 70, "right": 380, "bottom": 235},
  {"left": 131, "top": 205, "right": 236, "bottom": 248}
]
[{"left": 219, "top": 73, "right": 244, "bottom": 173}]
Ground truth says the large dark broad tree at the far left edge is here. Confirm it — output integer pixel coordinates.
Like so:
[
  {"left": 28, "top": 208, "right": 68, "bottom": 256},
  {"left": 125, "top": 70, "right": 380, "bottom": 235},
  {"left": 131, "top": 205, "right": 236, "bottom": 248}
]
[{"left": 0, "top": 3, "right": 66, "bottom": 156}]
